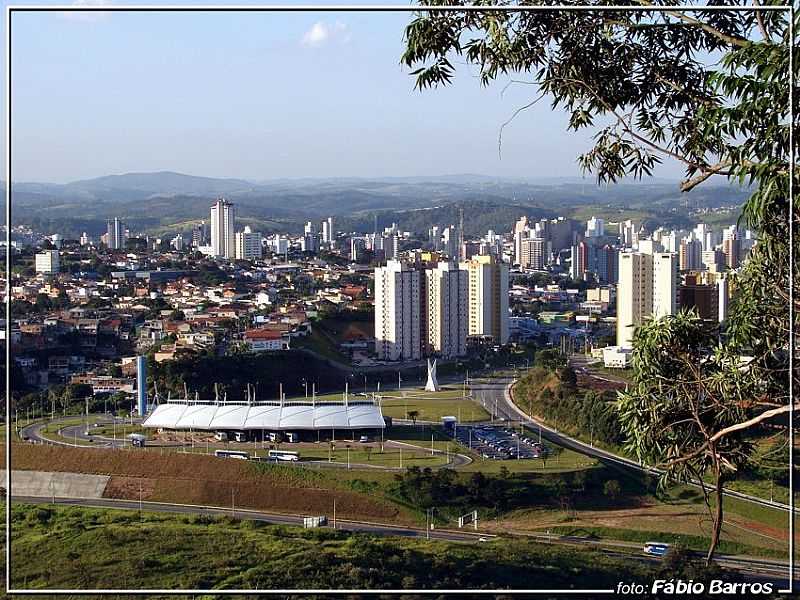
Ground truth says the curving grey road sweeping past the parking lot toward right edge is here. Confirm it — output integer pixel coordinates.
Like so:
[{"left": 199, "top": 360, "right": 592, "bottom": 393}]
[{"left": 472, "top": 377, "right": 800, "bottom": 514}]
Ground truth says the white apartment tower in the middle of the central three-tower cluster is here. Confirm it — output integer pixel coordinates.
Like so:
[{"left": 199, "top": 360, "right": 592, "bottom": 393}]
[{"left": 425, "top": 262, "right": 469, "bottom": 358}]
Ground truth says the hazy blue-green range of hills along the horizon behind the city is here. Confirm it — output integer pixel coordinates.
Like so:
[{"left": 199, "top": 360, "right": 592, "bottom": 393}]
[{"left": 3, "top": 171, "right": 748, "bottom": 235}]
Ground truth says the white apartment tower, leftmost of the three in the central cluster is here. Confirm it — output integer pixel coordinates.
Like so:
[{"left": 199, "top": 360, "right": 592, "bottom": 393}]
[{"left": 375, "top": 260, "right": 424, "bottom": 360}]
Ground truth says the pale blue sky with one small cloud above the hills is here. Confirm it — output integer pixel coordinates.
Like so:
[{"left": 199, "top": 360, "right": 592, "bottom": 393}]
[{"left": 0, "top": 0, "right": 680, "bottom": 183}]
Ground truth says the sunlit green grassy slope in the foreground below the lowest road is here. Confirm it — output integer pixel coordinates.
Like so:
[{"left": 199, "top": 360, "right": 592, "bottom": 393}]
[{"left": 12, "top": 505, "right": 652, "bottom": 590}]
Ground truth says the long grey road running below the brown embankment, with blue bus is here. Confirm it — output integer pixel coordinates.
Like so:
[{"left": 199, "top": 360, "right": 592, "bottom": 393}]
[{"left": 12, "top": 496, "right": 787, "bottom": 585}]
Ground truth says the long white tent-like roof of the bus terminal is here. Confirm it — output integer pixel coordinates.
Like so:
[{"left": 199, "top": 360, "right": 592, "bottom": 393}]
[{"left": 142, "top": 400, "right": 386, "bottom": 431}]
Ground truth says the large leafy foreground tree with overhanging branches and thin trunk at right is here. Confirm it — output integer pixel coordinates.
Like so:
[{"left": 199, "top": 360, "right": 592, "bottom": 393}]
[{"left": 402, "top": 0, "right": 800, "bottom": 557}]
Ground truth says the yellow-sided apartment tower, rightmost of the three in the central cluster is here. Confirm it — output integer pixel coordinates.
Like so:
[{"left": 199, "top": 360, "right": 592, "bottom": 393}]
[{"left": 461, "top": 255, "right": 509, "bottom": 344}]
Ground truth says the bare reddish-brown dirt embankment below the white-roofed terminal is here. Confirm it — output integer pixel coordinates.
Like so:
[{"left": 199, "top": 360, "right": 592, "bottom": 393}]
[{"left": 0, "top": 444, "right": 403, "bottom": 520}]
